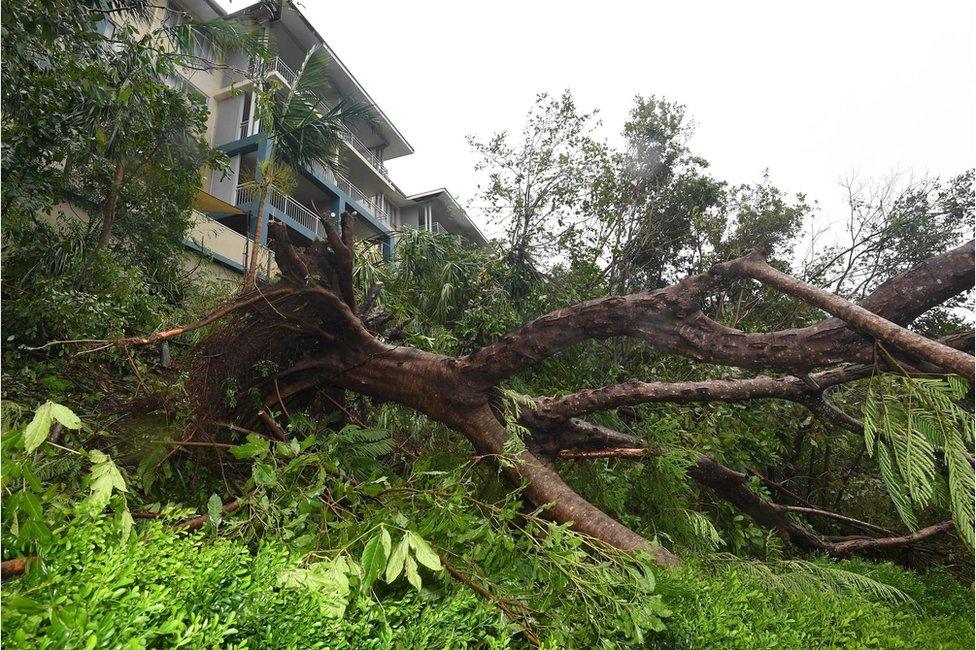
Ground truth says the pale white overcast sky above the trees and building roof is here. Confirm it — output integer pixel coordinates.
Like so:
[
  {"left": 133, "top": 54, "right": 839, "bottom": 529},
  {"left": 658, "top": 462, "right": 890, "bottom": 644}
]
[{"left": 225, "top": 0, "right": 976, "bottom": 238}]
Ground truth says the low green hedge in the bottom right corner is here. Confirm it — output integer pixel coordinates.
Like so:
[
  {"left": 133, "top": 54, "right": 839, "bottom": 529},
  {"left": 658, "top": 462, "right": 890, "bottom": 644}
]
[{"left": 654, "top": 562, "right": 974, "bottom": 650}]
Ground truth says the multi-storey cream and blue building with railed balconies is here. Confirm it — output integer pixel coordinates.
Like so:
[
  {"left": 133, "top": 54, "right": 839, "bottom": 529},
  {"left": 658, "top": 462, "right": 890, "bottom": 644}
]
[{"left": 150, "top": 0, "right": 486, "bottom": 270}]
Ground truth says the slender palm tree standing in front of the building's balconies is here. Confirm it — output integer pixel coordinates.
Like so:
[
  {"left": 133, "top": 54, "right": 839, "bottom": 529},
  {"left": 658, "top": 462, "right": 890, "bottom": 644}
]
[{"left": 244, "top": 46, "right": 377, "bottom": 290}]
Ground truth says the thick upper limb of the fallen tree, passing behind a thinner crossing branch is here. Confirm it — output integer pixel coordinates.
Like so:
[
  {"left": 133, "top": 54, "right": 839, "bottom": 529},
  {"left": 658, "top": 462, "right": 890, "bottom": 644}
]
[{"left": 459, "top": 242, "right": 974, "bottom": 385}]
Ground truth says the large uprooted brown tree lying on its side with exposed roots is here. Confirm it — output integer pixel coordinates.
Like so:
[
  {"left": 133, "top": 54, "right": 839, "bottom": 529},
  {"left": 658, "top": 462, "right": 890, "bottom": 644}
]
[{"left": 26, "top": 214, "right": 974, "bottom": 564}]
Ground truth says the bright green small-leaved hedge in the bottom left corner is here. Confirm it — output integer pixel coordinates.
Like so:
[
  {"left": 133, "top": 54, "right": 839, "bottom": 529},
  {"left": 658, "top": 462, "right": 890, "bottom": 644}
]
[{"left": 2, "top": 520, "right": 514, "bottom": 648}]
